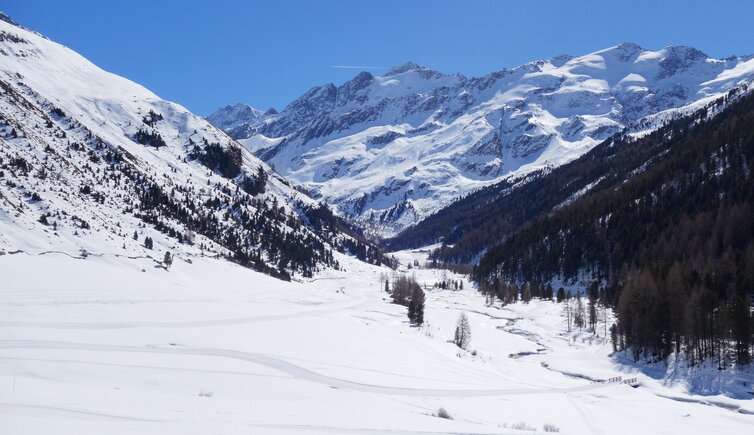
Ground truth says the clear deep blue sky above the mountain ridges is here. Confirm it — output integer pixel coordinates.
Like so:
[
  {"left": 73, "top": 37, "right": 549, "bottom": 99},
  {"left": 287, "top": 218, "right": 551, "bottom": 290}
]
[{"left": 5, "top": 0, "right": 754, "bottom": 115}]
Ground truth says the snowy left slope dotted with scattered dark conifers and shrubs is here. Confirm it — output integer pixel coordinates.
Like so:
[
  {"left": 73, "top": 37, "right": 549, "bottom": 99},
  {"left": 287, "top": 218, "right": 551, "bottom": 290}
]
[{"left": 0, "top": 15, "right": 379, "bottom": 277}]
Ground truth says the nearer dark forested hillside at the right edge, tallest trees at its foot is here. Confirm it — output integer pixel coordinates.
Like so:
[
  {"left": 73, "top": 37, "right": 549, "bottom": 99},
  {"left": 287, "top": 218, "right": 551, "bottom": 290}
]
[{"left": 476, "top": 87, "right": 754, "bottom": 364}]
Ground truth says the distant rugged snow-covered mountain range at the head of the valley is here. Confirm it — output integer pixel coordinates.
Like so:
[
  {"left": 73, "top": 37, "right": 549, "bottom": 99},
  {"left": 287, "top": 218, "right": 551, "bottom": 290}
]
[{"left": 211, "top": 43, "right": 754, "bottom": 235}]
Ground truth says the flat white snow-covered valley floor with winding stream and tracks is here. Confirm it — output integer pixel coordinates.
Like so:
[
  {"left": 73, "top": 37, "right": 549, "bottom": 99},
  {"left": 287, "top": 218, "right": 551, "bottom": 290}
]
[{"left": 0, "top": 253, "right": 754, "bottom": 434}]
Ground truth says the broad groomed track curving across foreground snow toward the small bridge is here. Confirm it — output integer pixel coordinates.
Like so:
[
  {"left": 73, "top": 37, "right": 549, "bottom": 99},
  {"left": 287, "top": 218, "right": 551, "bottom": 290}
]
[{"left": 0, "top": 340, "right": 610, "bottom": 397}]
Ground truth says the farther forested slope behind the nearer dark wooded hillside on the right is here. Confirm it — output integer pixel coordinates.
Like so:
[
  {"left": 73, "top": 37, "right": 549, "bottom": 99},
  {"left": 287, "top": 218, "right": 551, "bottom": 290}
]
[{"left": 385, "top": 84, "right": 741, "bottom": 263}]
